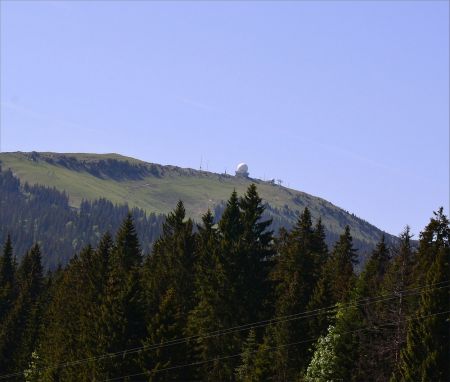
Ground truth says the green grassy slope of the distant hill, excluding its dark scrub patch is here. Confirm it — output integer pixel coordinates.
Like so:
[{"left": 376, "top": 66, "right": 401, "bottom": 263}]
[{"left": 0, "top": 153, "right": 392, "bottom": 251}]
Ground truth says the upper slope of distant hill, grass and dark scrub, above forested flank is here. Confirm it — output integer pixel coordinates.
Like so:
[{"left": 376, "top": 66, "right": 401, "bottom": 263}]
[{"left": 0, "top": 152, "right": 395, "bottom": 264}]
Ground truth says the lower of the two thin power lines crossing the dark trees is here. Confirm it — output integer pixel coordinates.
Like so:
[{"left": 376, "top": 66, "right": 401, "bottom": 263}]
[{"left": 104, "top": 310, "right": 450, "bottom": 382}]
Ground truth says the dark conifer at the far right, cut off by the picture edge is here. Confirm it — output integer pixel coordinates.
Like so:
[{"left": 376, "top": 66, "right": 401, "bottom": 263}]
[{"left": 398, "top": 209, "right": 450, "bottom": 382}]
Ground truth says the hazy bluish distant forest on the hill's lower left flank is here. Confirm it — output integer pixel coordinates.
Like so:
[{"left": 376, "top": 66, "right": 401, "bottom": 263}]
[{"left": 0, "top": 168, "right": 164, "bottom": 270}]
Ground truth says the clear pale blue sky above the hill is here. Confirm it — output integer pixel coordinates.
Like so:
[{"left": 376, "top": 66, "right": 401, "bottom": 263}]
[{"left": 1, "top": 0, "right": 449, "bottom": 238}]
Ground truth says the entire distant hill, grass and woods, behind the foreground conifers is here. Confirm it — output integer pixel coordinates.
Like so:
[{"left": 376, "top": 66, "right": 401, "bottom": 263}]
[{"left": 0, "top": 152, "right": 396, "bottom": 266}]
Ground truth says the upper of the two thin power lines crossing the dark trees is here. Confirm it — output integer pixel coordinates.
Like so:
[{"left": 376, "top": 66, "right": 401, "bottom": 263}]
[{"left": 0, "top": 281, "right": 444, "bottom": 380}]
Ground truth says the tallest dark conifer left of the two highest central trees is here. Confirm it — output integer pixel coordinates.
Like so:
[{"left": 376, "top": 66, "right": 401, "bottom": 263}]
[{"left": 141, "top": 201, "right": 196, "bottom": 380}]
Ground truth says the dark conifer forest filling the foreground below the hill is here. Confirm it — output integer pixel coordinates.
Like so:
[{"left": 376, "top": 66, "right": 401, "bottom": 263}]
[{"left": 0, "top": 185, "right": 450, "bottom": 382}]
